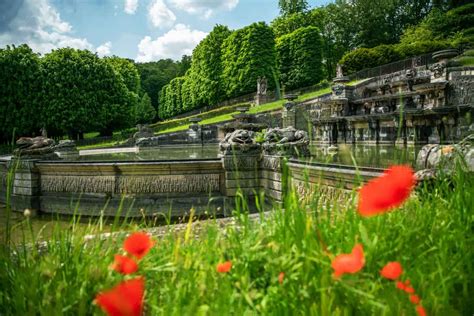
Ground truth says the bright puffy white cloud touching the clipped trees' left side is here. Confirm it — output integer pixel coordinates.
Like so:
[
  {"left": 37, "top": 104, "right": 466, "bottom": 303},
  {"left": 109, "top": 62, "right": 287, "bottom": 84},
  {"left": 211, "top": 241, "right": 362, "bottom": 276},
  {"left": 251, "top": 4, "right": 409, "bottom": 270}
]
[{"left": 136, "top": 24, "right": 207, "bottom": 62}]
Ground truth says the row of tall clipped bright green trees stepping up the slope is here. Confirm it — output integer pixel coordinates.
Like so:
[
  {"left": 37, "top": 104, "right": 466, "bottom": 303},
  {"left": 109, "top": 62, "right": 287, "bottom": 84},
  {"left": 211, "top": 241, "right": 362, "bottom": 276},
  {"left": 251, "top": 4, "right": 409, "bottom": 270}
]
[{"left": 158, "top": 22, "right": 278, "bottom": 119}]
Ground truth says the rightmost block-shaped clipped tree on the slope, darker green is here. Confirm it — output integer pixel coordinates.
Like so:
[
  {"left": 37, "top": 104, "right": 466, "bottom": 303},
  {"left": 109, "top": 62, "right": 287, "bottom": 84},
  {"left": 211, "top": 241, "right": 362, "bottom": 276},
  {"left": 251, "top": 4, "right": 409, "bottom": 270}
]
[{"left": 276, "top": 26, "right": 324, "bottom": 90}]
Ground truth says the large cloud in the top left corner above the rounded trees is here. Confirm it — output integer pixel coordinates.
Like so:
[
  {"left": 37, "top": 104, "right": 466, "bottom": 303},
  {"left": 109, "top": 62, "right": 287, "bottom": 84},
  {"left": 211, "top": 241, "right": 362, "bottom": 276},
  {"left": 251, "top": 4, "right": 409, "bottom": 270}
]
[{"left": 0, "top": 0, "right": 93, "bottom": 53}]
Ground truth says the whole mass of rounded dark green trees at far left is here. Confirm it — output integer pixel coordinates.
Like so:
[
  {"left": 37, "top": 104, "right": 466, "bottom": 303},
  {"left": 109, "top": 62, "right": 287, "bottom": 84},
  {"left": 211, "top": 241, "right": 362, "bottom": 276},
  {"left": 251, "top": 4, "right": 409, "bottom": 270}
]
[{"left": 0, "top": 45, "right": 146, "bottom": 142}]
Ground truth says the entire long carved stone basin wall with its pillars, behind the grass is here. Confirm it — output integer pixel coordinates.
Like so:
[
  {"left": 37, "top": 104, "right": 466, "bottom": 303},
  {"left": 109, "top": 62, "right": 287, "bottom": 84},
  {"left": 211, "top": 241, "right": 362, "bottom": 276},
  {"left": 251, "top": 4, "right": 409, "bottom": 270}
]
[{"left": 0, "top": 152, "right": 382, "bottom": 217}]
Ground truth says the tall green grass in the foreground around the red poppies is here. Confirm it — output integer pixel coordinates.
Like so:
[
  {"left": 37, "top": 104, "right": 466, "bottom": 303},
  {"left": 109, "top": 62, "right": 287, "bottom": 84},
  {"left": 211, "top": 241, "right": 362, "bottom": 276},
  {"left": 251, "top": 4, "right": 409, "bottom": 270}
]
[{"left": 0, "top": 164, "right": 474, "bottom": 315}]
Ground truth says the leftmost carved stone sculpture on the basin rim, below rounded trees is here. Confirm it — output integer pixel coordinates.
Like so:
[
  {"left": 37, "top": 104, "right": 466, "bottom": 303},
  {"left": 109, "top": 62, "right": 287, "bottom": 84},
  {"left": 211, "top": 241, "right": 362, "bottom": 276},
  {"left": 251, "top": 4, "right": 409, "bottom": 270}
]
[{"left": 13, "top": 136, "right": 57, "bottom": 159}]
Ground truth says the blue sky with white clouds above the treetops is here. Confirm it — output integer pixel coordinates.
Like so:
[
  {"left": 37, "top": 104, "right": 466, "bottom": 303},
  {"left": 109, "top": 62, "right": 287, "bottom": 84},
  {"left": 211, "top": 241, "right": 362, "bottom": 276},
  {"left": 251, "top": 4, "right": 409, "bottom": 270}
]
[{"left": 0, "top": 0, "right": 329, "bottom": 62}]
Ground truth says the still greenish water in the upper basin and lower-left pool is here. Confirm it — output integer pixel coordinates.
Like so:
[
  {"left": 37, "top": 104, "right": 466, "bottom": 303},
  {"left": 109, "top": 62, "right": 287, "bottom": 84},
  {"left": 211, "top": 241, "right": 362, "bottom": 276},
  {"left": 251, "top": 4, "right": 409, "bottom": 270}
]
[{"left": 0, "top": 145, "right": 420, "bottom": 242}]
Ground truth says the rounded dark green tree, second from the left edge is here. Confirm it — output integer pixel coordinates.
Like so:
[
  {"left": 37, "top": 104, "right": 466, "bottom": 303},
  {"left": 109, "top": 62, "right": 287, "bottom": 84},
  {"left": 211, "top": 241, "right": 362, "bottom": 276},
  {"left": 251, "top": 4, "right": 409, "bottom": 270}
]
[{"left": 42, "top": 48, "right": 135, "bottom": 139}]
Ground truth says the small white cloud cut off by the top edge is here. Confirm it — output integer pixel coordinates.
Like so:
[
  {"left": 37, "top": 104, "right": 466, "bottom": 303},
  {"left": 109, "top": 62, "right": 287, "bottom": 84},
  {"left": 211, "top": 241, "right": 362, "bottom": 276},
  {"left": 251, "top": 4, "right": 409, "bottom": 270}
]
[{"left": 170, "top": 0, "right": 239, "bottom": 19}]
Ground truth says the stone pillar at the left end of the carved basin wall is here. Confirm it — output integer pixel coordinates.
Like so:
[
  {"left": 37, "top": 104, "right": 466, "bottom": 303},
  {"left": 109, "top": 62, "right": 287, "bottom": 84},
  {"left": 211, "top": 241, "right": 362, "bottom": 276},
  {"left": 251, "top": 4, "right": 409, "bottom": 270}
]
[{"left": 8, "top": 158, "right": 41, "bottom": 214}]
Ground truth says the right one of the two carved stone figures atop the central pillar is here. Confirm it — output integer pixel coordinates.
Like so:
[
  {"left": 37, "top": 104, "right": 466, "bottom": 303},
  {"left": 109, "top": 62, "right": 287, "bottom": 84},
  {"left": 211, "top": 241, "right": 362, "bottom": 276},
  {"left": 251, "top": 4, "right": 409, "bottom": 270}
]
[{"left": 262, "top": 126, "right": 309, "bottom": 156}]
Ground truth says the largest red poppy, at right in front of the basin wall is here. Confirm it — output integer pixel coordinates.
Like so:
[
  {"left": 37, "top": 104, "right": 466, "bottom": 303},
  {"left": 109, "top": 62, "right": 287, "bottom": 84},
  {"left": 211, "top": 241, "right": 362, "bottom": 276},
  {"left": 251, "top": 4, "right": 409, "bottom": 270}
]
[{"left": 358, "top": 166, "right": 415, "bottom": 216}]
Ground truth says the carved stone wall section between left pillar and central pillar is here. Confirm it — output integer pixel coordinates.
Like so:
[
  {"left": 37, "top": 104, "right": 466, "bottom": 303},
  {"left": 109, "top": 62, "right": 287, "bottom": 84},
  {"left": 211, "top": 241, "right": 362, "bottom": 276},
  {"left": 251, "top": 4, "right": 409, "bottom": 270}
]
[{"left": 37, "top": 160, "right": 224, "bottom": 216}]
